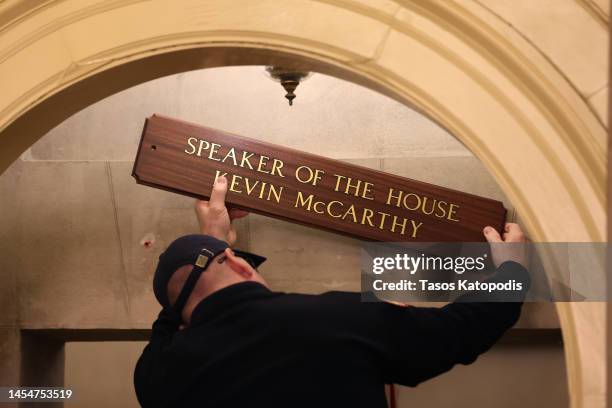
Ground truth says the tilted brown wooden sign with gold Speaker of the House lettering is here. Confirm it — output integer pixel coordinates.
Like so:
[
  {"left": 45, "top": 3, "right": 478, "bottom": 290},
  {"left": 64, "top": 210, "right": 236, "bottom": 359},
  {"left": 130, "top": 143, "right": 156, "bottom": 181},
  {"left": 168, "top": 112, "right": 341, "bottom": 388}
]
[{"left": 133, "top": 115, "right": 506, "bottom": 242}]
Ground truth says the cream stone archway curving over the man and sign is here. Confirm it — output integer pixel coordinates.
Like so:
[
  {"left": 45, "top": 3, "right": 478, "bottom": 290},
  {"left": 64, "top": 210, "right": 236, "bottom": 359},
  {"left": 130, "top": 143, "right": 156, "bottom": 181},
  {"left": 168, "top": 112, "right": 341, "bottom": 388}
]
[{"left": 0, "top": 0, "right": 606, "bottom": 407}]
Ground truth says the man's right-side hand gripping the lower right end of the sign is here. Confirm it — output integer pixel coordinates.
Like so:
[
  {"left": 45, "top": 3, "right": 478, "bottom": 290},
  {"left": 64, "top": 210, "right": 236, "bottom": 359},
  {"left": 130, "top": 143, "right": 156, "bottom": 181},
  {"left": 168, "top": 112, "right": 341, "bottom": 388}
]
[{"left": 483, "top": 223, "right": 528, "bottom": 268}]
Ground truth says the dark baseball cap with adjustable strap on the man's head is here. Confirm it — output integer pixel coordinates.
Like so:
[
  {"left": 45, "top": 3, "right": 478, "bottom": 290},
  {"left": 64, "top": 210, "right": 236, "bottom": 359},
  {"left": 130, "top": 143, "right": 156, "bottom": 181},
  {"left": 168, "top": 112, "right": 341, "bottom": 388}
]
[{"left": 153, "top": 234, "right": 266, "bottom": 313}]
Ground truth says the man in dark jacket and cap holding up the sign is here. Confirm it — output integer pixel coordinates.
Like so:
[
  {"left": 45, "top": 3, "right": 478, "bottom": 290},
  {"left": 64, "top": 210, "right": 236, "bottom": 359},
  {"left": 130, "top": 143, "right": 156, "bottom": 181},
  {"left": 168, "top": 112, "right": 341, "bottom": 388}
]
[{"left": 134, "top": 178, "right": 529, "bottom": 408}]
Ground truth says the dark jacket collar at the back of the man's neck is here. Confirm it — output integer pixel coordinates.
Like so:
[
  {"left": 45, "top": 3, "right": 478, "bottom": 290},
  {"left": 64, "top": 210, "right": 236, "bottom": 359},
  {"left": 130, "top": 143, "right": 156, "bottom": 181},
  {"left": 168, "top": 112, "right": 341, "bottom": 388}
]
[{"left": 191, "top": 281, "right": 276, "bottom": 326}]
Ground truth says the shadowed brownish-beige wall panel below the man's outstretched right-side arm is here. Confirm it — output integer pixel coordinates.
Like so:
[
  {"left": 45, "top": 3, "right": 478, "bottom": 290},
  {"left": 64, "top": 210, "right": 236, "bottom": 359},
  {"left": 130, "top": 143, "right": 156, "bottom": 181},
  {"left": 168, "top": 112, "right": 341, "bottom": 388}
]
[{"left": 397, "top": 344, "right": 568, "bottom": 408}]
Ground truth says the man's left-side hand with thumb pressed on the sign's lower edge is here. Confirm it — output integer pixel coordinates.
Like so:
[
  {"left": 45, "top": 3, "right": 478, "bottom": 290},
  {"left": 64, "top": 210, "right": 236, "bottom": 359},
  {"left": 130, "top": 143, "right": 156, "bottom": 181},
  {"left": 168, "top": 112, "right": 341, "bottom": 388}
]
[{"left": 195, "top": 176, "right": 248, "bottom": 245}]
